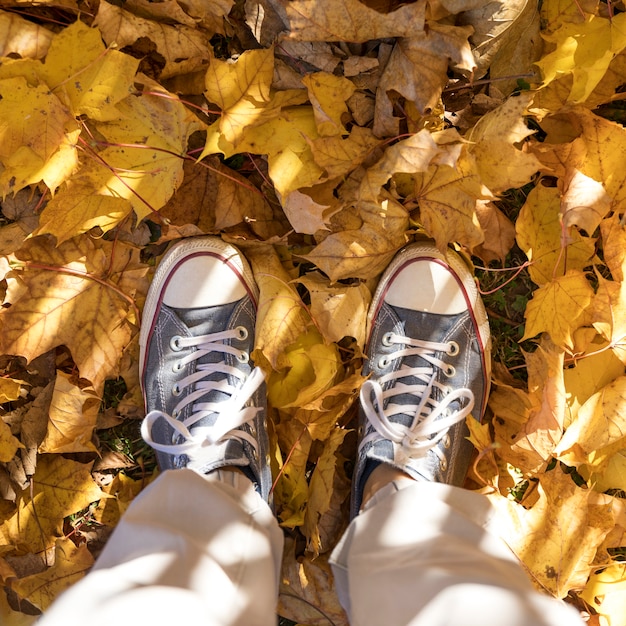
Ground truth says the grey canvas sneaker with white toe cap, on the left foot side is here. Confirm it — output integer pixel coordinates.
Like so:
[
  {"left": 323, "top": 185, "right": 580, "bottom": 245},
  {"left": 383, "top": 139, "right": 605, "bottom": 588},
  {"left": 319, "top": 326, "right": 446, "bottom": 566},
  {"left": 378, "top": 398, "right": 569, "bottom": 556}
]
[{"left": 139, "top": 237, "right": 271, "bottom": 501}]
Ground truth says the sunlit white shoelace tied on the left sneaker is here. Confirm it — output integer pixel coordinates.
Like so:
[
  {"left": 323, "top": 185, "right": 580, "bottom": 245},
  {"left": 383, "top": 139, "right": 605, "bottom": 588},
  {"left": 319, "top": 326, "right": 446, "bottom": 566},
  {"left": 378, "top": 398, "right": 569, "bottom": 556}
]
[{"left": 141, "top": 327, "right": 265, "bottom": 459}]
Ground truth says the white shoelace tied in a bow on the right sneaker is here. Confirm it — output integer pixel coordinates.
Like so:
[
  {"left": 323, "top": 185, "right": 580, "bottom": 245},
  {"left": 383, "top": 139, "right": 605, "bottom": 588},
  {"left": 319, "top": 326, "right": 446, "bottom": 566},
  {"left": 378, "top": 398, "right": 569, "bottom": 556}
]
[{"left": 361, "top": 333, "right": 474, "bottom": 471}]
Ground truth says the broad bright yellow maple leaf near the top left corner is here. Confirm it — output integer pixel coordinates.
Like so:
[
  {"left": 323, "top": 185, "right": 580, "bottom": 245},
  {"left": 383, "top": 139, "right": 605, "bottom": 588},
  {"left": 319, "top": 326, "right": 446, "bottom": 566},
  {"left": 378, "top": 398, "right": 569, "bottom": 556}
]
[{"left": 41, "top": 20, "right": 139, "bottom": 120}]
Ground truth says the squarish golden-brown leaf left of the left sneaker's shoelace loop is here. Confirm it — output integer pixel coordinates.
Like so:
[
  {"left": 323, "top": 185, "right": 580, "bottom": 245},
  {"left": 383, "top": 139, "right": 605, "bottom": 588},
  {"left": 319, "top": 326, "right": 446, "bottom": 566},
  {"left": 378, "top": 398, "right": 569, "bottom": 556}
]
[{"left": 39, "top": 371, "right": 100, "bottom": 454}]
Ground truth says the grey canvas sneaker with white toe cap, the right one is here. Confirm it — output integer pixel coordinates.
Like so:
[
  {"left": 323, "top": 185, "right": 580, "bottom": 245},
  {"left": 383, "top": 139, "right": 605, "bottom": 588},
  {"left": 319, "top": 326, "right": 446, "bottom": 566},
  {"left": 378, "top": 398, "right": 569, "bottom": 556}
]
[{"left": 352, "top": 242, "right": 490, "bottom": 516}]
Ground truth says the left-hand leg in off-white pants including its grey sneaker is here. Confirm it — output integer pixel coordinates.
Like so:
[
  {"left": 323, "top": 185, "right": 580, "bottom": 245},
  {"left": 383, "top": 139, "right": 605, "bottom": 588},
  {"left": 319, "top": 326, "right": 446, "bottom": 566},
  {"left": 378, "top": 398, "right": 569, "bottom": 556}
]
[{"left": 42, "top": 237, "right": 282, "bottom": 626}]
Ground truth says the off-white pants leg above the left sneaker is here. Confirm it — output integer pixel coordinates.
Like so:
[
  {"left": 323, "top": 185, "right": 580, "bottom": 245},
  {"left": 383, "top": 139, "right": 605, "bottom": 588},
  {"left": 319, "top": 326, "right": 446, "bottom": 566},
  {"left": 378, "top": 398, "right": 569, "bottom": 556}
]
[{"left": 39, "top": 469, "right": 283, "bottom": 626}]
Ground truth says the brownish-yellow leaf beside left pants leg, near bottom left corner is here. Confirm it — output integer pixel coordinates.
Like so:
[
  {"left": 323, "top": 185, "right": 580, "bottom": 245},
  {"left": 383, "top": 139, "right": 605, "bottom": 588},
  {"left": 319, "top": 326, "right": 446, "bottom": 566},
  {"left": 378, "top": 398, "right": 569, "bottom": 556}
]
[{"left": 12, "top": 538, "right": 94, "bottom": 611}]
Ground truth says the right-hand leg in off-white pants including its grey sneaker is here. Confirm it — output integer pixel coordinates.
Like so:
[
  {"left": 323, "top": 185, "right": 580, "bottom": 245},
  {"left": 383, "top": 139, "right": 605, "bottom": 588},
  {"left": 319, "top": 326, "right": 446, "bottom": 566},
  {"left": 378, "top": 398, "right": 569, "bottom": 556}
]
[{"left": 331, "top": 244, "right": 581, "bottom": 626}]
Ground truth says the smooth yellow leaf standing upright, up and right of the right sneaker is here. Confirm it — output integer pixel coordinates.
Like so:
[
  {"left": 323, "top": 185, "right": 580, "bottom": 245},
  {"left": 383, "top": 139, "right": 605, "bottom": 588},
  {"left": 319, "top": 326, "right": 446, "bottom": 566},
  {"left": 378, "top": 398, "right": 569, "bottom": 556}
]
[{"left": 515, "top": 184, "right": 595, "bottom": 285}]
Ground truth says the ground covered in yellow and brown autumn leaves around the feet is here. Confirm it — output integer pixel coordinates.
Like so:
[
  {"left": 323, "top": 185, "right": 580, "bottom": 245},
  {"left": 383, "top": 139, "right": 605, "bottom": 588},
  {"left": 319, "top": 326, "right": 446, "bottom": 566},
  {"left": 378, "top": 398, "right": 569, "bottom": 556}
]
[{"left": 0, "top": 0, "right": 626, "bottom": 626}]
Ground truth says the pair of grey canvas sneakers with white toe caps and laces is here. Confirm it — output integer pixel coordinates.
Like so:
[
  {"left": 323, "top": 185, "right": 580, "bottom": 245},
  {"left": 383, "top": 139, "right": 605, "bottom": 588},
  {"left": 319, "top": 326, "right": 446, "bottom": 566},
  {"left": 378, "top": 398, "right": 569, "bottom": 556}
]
[{"left": 140, "top": 237, "right": 490, "bottom": 516}]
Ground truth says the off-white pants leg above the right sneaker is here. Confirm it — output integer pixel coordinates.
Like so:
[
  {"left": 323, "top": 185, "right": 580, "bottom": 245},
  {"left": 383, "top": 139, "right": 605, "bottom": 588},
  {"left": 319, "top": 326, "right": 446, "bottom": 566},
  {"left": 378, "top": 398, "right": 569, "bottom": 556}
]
[{"left": 331, "top": 479, "right": 584, "bottom": 626}]
